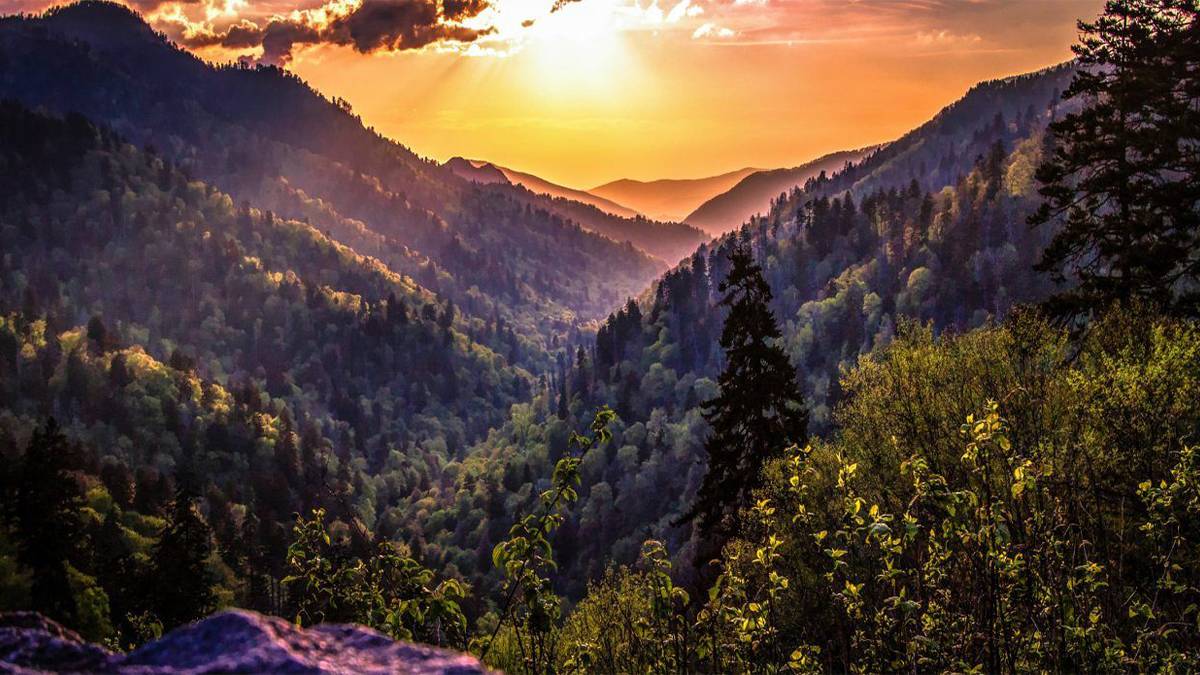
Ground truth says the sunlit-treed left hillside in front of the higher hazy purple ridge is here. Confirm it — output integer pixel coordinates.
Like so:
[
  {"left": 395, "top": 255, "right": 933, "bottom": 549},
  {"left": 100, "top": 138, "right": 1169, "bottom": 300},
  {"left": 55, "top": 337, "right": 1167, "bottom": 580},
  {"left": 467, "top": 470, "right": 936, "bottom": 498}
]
[{"left": 0, "top": 103, "right": 535, "bottom": 634}]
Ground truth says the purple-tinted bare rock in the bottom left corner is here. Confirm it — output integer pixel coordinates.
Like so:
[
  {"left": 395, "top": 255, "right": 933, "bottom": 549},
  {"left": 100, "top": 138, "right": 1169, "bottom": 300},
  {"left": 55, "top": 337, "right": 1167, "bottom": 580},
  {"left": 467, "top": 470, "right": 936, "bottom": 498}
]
[{"left": 0, "top": 610, "right": 488, "bottom": 675}]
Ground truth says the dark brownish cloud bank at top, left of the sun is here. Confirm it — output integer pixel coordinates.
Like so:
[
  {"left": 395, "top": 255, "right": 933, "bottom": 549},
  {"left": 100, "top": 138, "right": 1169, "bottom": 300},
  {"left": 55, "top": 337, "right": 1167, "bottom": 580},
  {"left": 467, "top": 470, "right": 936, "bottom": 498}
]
[{"left": 181, "top": 0, "right": 492, "bottom": 65}]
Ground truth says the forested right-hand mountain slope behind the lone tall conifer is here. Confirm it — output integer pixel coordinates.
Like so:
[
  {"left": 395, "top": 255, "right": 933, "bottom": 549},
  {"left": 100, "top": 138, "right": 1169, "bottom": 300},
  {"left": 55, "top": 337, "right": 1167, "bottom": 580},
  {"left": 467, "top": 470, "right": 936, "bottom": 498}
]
[{"left": 444, "top": 60, "right": 1074, "bottom": 593}]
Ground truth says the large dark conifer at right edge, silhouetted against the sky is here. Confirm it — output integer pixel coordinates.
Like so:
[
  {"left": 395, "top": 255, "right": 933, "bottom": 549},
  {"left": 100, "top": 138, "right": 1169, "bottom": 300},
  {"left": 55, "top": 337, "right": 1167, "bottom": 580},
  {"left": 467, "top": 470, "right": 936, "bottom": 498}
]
[{"left": 1030, "top": 0, "right": 1200, "bottom": 316}]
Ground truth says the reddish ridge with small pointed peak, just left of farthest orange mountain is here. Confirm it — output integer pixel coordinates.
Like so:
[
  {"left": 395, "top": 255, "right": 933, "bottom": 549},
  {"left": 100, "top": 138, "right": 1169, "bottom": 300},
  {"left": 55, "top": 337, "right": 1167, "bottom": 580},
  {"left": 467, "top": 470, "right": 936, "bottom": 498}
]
[{"left": 443, "top": 157, "right": 709, "bottom": 264}]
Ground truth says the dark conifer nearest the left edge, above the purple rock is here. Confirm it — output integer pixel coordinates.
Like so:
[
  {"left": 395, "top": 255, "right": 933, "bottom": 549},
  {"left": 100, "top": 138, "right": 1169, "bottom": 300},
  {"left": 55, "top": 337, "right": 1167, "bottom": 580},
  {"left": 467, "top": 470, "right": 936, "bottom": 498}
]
[{"left": 12, "top": 417, "right": 83, "bottom": 621}]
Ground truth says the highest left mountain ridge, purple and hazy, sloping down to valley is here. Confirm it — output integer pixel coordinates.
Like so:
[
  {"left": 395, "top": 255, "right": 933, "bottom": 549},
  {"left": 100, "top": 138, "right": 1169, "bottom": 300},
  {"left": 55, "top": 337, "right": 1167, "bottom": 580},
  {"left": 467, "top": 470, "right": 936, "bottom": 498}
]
[{"left": 0, "top": 0, "right": 666, "bottom": 368}]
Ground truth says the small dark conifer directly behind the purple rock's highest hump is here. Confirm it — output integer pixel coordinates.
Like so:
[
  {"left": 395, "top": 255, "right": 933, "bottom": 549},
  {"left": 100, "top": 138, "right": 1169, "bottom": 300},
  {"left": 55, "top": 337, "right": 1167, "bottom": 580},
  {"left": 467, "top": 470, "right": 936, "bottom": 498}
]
[{"left": 154, "top": 480, "right": 216, "bottom": 629}]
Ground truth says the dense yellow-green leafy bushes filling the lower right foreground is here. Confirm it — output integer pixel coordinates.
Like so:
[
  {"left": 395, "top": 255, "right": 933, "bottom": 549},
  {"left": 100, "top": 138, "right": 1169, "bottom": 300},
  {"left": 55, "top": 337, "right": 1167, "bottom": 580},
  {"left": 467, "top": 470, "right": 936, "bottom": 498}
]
[{"left": 719, "top": 315, "right": 1200, "bottom": 671}]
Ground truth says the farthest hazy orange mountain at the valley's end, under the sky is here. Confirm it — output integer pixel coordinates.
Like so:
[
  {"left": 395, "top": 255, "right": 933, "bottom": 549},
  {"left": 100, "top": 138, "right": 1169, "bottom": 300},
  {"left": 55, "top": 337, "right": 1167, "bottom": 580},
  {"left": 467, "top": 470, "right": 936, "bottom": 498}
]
[{"left": 588, "top": 168, "right": 758, "bottom": 222}]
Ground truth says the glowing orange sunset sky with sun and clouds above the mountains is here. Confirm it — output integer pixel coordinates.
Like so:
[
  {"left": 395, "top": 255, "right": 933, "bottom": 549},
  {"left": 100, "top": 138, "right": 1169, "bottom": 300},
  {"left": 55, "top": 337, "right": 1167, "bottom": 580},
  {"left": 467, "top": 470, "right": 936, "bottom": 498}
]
[{"left": 7, "top": 0, "right": 1103, "bottom": 189}]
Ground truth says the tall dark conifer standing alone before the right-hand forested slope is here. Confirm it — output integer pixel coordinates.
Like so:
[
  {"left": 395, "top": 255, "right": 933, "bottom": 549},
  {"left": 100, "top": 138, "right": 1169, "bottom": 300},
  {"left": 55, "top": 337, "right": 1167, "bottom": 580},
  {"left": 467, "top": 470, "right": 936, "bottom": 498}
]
[{"left": 683, "top": 246, "right": 809, "bottom": 540}]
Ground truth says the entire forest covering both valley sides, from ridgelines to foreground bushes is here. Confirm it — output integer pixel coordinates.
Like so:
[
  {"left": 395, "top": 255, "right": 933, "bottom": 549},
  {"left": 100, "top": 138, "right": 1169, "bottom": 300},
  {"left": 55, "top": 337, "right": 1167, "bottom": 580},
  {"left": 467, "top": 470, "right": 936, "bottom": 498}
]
[{"left": 0, "top": 0, "right": 1200, "bottom": 674}]
